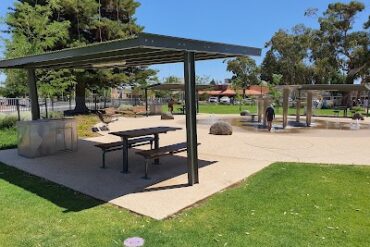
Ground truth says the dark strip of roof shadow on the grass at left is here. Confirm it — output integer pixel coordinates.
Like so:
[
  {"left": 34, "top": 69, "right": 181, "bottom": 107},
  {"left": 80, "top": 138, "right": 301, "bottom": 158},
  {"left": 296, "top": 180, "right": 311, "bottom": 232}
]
[{"left": 0, "top": 163, "right": 104, "bottom": 213}]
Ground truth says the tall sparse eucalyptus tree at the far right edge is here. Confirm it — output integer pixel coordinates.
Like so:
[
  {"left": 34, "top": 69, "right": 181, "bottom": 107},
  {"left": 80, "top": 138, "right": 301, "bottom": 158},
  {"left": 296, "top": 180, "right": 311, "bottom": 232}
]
[{"left": 312, "top": 1, "right": 370, "bottom": 84}]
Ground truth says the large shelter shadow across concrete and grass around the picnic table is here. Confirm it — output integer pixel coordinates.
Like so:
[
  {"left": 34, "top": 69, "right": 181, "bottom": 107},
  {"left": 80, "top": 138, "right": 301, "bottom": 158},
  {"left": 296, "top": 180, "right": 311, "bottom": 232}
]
[{"left": 0, "top": 138, "right": 216, "bottom": 212}]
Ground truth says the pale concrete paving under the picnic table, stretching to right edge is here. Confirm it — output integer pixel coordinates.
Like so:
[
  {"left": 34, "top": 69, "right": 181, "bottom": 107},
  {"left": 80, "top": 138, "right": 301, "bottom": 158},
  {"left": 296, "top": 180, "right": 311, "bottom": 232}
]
[{"left": 0, "top": 114, "right": 370, "bottom": 219}]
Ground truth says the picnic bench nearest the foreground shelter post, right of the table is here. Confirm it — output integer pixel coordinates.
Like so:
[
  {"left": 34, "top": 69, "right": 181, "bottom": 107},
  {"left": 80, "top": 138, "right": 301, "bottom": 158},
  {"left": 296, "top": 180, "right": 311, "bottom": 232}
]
[{"left": 136, "top": 142, "right": 199, "bottom": 179}]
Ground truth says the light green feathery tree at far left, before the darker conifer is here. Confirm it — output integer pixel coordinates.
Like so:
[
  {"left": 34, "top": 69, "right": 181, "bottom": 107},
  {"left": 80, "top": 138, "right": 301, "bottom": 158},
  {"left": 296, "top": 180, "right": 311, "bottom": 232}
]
[{"left": 5, "top": 1, "right": 69, "bottom": 97}]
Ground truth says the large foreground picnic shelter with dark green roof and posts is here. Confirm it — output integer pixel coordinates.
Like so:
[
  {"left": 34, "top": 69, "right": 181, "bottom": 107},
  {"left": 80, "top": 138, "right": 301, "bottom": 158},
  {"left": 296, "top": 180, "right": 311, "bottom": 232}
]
[{"left": 0, "top": 33, "right": 261, "bottom": 185}]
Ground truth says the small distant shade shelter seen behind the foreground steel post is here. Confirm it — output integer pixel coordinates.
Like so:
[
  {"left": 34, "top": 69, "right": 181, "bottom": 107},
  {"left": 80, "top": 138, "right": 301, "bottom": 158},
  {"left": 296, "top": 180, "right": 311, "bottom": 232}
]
[{"left": 144, "top": 83, "right": 214, "bottom": 116}]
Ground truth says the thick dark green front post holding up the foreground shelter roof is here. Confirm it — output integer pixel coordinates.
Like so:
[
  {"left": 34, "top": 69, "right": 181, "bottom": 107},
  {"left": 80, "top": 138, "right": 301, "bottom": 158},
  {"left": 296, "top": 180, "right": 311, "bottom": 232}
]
[{"left": 184, "top": 51, "right": 199, "bottom": 185}]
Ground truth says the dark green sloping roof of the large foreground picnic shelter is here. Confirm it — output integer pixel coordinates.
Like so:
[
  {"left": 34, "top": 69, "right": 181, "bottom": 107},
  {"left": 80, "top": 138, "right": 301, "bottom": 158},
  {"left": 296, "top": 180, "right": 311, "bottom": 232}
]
[{"left": 0, "top": 33, "right": 261, "bottom": 69}]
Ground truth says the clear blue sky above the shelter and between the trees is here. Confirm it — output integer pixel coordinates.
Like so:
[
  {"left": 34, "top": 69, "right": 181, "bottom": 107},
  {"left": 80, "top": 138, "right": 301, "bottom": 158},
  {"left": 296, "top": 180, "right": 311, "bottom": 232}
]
[{"left": 0, "top": 0, "right": 370, "bottom": 81}]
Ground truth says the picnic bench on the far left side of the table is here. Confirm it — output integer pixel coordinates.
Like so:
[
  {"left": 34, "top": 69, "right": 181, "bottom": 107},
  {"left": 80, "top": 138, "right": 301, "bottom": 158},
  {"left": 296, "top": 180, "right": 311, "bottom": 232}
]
[{"left": 95, "top": 136, "right": 154, "bottom": 168}]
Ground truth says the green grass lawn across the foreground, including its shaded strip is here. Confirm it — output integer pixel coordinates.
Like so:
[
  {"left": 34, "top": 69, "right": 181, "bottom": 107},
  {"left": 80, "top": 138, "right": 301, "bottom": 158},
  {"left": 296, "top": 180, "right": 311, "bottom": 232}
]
[{"left": 0, "top": 163, "right": 370, "bottom": 247}]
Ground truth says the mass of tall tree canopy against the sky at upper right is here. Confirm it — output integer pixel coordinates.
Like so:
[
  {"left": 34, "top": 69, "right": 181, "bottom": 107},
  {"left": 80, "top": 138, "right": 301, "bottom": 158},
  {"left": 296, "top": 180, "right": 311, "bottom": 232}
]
[{"left": 261, "top": 1, "right": 370, "bottom": 84}]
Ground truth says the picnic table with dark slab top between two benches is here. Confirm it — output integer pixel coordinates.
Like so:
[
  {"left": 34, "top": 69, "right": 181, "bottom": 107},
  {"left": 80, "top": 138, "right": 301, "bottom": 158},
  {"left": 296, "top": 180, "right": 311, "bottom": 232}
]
[{"left": 109, "top": 127, "right": 181, "bottom": 173}]
